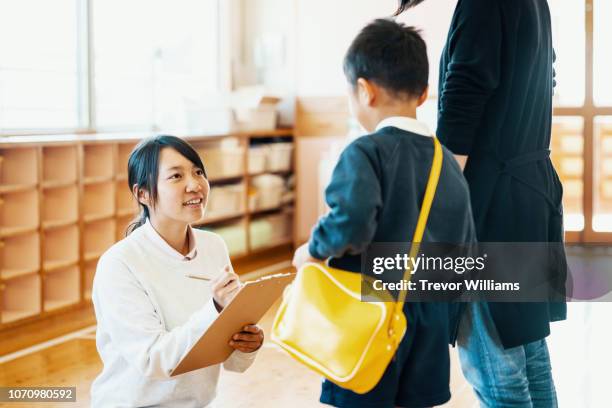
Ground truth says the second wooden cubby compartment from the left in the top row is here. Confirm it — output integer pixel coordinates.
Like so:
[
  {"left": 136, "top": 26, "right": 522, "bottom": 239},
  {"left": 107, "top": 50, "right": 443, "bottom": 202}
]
[{"left": 42, "top": 146, "right": 78, "bottom": 186}]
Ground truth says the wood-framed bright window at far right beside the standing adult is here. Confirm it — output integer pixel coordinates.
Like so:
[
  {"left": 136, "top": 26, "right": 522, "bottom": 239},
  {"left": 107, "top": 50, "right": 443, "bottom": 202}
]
[{"left": 549, "top": 0, "right": 612, "bottom": 242}]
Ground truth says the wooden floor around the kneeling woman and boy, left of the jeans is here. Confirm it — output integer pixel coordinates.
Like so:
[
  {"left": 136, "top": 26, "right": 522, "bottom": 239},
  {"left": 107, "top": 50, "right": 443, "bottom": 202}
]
[{"left": 0, "top": 298, "right": 475, "bottom": 408}]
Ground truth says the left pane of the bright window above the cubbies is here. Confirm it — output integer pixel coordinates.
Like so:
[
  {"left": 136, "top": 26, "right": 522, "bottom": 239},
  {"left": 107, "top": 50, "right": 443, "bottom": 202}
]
[{"left": 0, "top": 0, "right": 82, "bottom": 132}]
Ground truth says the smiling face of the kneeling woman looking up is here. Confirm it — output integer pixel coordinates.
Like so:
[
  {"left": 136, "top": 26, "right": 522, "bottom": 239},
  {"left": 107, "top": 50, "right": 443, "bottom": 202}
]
[{"left": 149, "top": 147, "right": 210, "bottom": 224}]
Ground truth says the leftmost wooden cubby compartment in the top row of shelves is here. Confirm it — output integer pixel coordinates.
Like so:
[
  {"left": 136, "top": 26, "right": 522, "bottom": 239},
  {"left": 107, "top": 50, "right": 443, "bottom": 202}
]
[{"left": 0, "top": 147, "right": 38, "bottom": 191}]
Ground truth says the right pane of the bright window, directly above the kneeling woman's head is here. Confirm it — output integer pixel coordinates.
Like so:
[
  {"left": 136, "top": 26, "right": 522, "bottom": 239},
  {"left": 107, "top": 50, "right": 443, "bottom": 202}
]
[{"left": 93, "top": 0, "right": 219, "bottom": 128}]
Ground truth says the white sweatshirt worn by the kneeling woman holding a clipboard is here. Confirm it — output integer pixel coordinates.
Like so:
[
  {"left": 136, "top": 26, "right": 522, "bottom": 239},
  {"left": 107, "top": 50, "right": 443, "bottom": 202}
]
[{"left": 91, "top": 222, "right": 256, "bottom": 408}]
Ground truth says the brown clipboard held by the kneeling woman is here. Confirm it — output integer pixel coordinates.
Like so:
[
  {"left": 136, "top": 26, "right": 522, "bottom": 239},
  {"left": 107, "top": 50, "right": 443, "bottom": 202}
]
[{"left": 170, "top": 273, "right": 295, "bottom": 377}]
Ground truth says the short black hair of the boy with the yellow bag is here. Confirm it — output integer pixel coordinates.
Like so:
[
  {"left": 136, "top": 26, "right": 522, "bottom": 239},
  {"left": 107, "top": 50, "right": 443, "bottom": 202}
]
[{"left": 344, "top": 19, "right": 429, "bottom": 98}]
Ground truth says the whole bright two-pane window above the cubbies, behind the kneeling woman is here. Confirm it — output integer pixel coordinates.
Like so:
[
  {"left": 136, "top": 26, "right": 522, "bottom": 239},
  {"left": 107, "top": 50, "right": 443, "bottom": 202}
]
[{"left": 0, "top": 0, "right": 226, "bottom": 133}]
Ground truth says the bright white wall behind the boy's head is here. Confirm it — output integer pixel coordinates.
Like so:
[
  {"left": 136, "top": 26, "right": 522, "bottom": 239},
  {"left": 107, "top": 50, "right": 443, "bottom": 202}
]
[{"left": 236, "top": 0, "right": 456, "bottom": 96}]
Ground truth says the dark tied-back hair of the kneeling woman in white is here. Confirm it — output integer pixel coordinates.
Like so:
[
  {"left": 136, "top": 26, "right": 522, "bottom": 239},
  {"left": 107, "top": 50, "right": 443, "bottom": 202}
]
[{"left": 125, "top": 135, "right": 207, "bottom": 236}]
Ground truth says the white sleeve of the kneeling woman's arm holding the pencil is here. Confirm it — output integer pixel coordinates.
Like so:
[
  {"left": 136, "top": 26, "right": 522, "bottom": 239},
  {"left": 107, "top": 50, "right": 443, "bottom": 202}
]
[{"left": 93, "top": 256, "right": 218, "bottom": 379}]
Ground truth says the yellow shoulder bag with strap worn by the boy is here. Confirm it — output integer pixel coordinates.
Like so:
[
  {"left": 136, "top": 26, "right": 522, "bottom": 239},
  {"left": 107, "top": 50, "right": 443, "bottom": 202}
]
[{"left": 271, "top": 138, "right": 443, "bottom": 394}]
